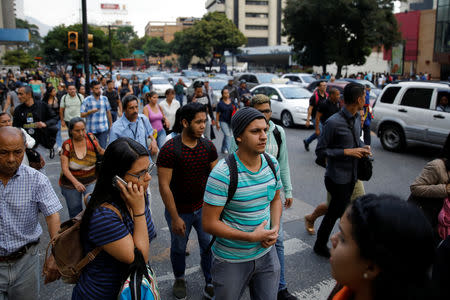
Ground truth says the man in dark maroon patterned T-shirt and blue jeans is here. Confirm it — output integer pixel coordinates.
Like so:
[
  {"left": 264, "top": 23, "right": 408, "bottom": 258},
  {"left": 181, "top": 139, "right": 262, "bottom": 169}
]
[{"left": 157, "top": 102, "right": 218, "bottom": 299}]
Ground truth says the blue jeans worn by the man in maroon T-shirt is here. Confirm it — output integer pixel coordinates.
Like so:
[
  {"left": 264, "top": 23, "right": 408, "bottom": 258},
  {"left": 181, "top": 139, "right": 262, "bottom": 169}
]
[{"left": 164, "top": 208, "right": 212, "bottom": 283}]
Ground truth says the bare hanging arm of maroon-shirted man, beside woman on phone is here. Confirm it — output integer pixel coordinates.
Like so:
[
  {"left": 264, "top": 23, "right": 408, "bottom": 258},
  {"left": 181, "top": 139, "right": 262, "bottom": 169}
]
[{"left": 158, "top": 167, "right": 186, "bottom": 236}]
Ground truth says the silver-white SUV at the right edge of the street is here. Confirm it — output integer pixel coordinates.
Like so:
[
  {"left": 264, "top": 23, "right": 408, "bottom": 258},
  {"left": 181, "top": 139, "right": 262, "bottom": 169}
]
[{"left": 371, "top": 81, "right": 450, "bottom": 151}]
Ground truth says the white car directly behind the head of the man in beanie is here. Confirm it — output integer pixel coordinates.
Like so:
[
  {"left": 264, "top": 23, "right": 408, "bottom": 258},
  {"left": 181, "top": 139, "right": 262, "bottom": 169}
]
[{"left": 250, "top": 84, "right": 311, "bottom": 127}]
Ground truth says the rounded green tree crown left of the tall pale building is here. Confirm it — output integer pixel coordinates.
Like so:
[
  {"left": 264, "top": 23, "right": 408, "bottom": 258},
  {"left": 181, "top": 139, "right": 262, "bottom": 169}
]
[{"left": 171, "top": 12, "right": 247, "bottom": 66}]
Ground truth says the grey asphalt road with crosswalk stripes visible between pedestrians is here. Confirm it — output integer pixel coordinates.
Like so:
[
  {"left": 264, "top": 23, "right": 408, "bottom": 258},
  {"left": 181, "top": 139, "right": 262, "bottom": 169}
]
[{"left": 36, "top": 120, "right": 439, "bottom": 299}]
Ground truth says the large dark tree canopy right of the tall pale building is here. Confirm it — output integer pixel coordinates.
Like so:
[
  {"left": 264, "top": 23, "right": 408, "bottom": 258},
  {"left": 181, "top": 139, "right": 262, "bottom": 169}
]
[{"left": 283, "top": 0, "right": 401, "bottom": 75}]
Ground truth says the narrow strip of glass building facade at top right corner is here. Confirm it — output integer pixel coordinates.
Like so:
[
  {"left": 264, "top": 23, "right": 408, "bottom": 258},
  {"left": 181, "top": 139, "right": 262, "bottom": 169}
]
[{"left": 434, "top": 0, "right": 450, "bottom": 53}]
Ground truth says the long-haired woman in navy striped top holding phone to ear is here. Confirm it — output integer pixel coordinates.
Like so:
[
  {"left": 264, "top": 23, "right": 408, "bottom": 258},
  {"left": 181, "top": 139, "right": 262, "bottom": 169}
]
[{"left": 72, "top": 138, "right": 156, "bottom": 299}]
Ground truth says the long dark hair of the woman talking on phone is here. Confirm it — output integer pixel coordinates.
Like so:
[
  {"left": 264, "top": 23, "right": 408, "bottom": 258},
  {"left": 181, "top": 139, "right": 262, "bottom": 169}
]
[{"left": 80, "top": 138, "right": 148, "bottom": 244}]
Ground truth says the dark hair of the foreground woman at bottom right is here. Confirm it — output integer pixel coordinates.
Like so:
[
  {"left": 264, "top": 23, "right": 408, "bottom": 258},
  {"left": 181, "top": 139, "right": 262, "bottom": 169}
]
[{"left": 347, "top": 194, "right": 435, "bottom": 300}]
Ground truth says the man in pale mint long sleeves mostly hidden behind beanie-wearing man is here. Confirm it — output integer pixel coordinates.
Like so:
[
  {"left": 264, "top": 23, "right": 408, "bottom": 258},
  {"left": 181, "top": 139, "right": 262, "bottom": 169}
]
[{"left": 231, "top": 94, "right": 297, "bottom": 300}]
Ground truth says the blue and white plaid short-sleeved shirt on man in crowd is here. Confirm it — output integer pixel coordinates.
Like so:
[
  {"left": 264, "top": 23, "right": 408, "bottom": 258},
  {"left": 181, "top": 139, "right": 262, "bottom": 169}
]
[{"left": 81, "top": 96, "right": 111, "bottom": 133}]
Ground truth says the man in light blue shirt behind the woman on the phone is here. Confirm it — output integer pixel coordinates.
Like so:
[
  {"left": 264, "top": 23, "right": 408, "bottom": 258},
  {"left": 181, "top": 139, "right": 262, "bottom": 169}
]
[{"left": 109, "top": 95, "right": 158, "bottom": 155}]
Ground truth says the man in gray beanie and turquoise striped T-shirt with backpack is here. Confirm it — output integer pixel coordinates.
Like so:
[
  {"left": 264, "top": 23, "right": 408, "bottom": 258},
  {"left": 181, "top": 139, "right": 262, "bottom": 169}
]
[{"left": 202, "top": 107, "right": 283, "bottom": 300}]
